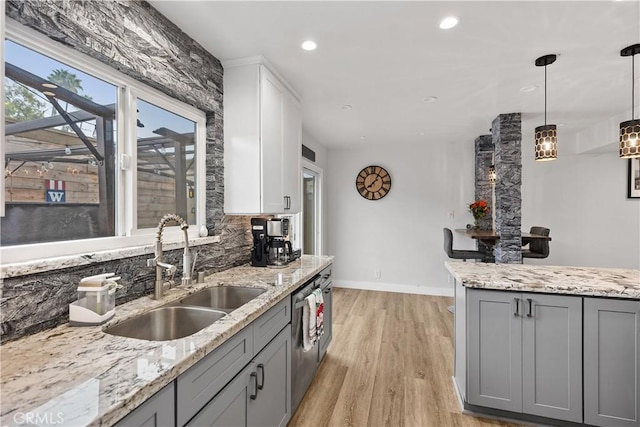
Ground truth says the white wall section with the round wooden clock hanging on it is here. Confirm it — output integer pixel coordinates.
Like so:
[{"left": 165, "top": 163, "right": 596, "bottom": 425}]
[{"left": 325, "top": 142, "right": 474, "bottom": 295}]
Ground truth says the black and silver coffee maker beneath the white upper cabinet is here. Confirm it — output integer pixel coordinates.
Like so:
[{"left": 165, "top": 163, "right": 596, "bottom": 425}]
[{"left": 251, "top": 218, "right": 300, "bottom": 268}]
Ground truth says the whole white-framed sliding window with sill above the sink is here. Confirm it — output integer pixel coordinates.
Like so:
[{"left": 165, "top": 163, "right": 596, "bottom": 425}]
[{"left": 0, "top": 25, "right": 205, "bottom": 262}]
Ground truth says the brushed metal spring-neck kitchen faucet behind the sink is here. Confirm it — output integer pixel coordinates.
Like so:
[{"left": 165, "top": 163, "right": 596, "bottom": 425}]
[{"left": 147, "top": 214, "right": 191, "bottom": 299}]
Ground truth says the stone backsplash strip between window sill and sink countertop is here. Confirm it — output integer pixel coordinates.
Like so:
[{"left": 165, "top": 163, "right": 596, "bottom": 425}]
[{"left": 0, "top": 217, "right": 252, "bottom": 342}]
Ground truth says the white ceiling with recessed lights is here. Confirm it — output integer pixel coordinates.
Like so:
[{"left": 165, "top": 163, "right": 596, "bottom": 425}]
[{"left": 150, "top": 0, "right": 640, "bottom": 148}]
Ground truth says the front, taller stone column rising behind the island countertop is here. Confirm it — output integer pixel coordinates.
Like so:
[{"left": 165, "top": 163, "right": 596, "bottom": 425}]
[{"left": 491, "top": 113, "right": 522, "bottom": 264}]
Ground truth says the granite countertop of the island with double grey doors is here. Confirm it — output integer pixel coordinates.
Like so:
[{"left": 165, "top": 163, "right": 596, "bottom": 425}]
[{"left": 445, "top": 261, "right": 640, "bottom": 299}]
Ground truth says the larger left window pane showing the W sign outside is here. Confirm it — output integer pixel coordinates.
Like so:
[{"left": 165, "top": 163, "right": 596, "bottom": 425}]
[{"left": 1, "top": 40, "right": 117, "bottom": 245}]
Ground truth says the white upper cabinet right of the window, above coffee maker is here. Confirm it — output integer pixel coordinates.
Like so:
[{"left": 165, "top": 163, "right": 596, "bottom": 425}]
[{"left": 224, "top": 58, "right": 302, "bottom": 214}]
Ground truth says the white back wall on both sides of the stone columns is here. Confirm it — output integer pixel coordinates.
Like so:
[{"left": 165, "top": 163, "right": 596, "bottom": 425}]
[{"left": 325, "top": 139, "right": 640, "bottom": 295}]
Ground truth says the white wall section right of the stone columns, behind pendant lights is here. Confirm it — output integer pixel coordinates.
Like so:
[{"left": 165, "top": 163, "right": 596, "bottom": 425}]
[{"left": 522, "top": 147, "right": 640, "bottom": 269}]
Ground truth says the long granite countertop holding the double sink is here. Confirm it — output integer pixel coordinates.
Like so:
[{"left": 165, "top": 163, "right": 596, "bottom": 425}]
[{"left": 0, "top": 255, "right": 333, "bottom": 426}]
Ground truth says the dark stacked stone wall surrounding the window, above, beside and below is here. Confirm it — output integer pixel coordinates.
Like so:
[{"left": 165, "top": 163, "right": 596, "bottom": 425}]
[{"left": 0, "top": 0, "right": 251, "bottom": 342}]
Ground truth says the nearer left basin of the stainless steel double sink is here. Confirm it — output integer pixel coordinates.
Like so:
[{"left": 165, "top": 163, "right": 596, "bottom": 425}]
[{"left": 105, "top": 306, "right": 226, "bottom": 341}]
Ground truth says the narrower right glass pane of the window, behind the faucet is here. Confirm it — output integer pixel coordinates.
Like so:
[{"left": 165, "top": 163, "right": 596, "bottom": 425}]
[{"left": 137, "top": 99, "right": 197, "bottom": 228}]
